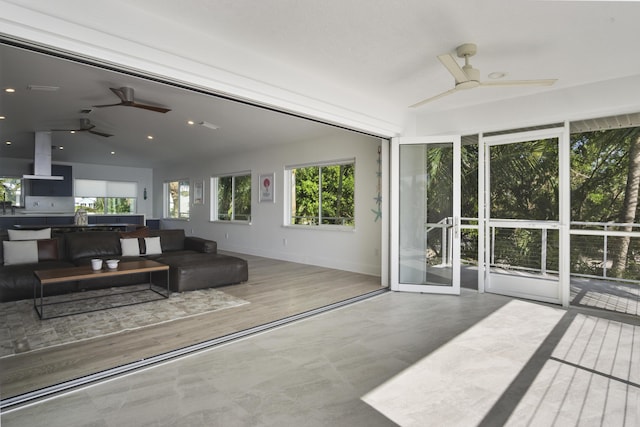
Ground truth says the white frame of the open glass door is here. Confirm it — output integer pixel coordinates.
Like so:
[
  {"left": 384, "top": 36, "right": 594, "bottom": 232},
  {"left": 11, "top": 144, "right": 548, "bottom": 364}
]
[{"left": 389, "top": 135, "right": 462, "bottom": 295}]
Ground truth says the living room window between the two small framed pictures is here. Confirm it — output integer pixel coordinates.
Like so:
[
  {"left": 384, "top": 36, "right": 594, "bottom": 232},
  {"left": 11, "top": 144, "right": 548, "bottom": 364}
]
[{"left": 211, "top": 172, "right": 251, "bottom": 222}]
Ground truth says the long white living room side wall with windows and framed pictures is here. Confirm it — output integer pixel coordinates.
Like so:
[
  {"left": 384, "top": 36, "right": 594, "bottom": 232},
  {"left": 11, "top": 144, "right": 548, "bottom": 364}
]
[{"left": 154, "top": 132, "right": 382, "bottom": 275}]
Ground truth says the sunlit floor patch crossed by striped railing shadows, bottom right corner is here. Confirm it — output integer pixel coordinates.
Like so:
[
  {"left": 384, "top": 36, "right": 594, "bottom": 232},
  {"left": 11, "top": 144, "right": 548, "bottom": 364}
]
[{"left": 507, "top": 314, "right": 640, "bottom": 426}]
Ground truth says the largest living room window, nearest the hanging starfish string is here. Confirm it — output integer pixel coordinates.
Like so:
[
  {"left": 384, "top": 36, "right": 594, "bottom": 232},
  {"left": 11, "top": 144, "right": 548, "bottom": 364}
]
[{"left": 286, "top": 159, "right": 355, "bottom": 227}]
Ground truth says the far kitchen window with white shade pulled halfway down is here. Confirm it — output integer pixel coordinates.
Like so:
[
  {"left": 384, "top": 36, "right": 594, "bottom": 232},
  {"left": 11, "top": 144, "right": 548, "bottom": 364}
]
[{"left": 73, "top": 179, "right": 138, "bottom": 214}]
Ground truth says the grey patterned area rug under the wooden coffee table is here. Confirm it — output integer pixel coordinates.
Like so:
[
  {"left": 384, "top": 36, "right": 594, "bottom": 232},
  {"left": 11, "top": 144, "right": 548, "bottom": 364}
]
[{"left": 0, "top": 285, "right": 249, "bottom": 358}]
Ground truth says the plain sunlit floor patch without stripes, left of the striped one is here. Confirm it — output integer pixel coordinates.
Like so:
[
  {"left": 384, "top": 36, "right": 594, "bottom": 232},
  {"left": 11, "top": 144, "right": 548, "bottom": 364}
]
[{"left": 362, "top": 300, "right": 565, "bottom": 426}]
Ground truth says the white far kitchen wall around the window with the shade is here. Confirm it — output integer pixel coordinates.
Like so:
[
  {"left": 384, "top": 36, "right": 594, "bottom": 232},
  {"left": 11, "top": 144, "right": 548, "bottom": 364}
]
[{"left": 0, "top": 158, "right": 153, "bottom": 218}]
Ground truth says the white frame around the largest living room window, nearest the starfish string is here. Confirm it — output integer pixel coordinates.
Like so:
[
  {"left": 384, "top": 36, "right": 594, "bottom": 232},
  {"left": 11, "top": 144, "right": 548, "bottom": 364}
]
[{"left": 283, "top": 158, "right": 357, "bottom": 231}]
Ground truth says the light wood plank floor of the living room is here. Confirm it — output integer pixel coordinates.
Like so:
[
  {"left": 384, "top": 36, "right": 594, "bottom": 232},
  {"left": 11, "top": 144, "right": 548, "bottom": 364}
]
[{"left": 0, "top": 254, "right": 380, "bottom": 399}]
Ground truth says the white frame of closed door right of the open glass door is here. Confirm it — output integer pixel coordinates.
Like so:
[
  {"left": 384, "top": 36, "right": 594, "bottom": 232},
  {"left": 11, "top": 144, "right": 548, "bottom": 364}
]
[{"left": 478, "top": 123, "right": 571, "bottom": 307}]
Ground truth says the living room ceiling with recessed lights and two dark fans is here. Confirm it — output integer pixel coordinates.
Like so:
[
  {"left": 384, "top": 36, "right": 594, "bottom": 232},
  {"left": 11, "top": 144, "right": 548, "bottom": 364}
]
[{"left": 0, "top": 41, "right": 344, "bottom": 167}]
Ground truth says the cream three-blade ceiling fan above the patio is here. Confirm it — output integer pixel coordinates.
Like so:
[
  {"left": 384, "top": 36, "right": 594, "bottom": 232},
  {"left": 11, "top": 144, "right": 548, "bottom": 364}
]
[{"left": 410, "top": 43, "right": 557, "bottom": 108}]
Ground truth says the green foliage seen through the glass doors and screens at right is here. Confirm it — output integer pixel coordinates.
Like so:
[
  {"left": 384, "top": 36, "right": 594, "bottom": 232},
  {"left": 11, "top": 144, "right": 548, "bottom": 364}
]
[{"left": 404, "top": 128, "right": 640, "bottom": 279}]
